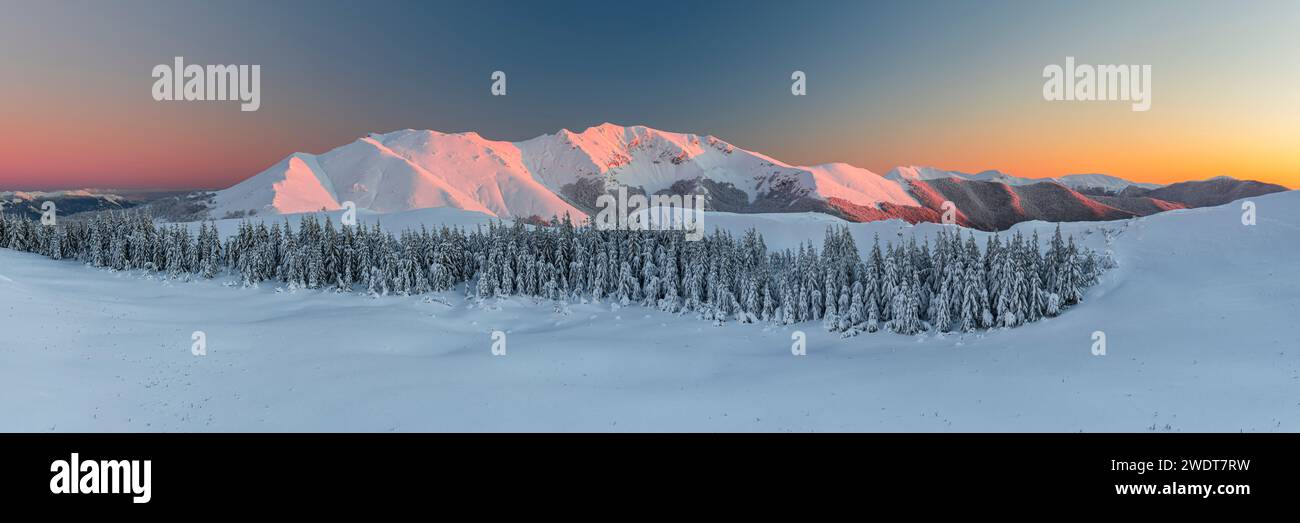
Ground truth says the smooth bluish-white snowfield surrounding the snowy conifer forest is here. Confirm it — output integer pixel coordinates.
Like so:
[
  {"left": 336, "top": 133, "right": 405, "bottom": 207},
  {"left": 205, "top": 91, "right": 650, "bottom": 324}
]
[{"left": 0, "top": 191, "right": 1300, "bottom": 432}]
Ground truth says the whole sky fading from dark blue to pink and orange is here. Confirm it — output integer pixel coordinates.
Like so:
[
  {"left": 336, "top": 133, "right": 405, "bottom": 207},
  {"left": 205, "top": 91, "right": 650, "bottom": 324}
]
[{"left": 0, "top": 0, "right": 1300, "bottom": 190}]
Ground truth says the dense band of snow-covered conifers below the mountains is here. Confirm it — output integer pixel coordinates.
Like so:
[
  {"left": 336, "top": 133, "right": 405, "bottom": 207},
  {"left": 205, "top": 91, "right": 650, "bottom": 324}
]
[{"left": 0, "top": 213, "right": 1113, "bottom": 336}]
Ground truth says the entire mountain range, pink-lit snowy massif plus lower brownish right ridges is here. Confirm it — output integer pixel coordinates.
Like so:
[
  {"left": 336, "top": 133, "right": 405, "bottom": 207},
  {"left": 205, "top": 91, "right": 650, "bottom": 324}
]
[{"left": 208, "top": 124, "right": 1286, "bottom": 229}]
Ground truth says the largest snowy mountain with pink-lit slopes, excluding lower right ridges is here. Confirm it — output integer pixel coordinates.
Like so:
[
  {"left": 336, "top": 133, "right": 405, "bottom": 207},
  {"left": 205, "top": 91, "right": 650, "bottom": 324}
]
[{"left": 209, "top": 122, "right": 918, "bottom": 219}]
